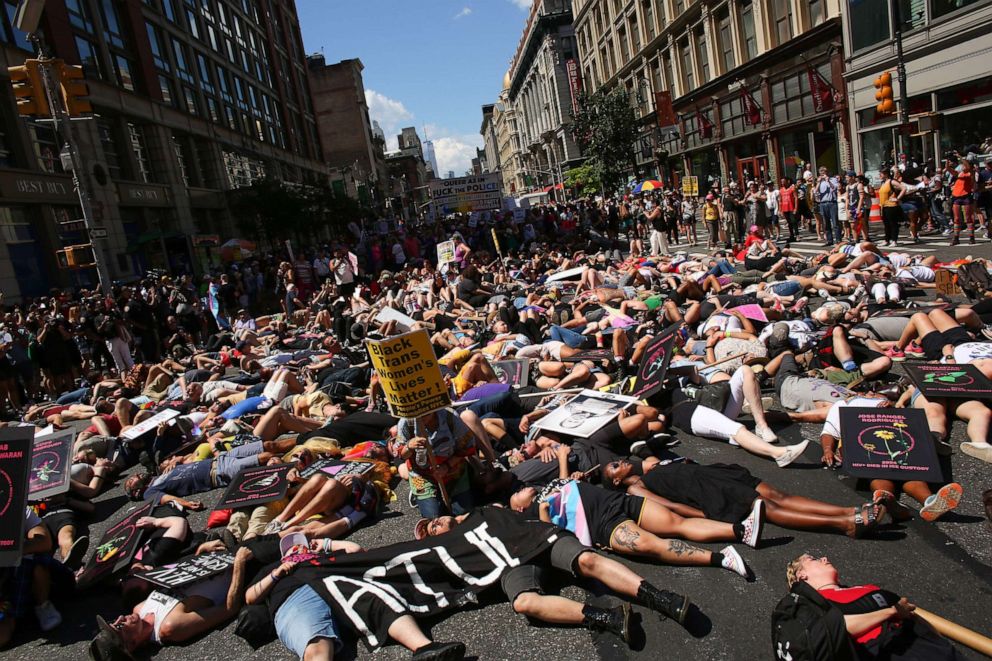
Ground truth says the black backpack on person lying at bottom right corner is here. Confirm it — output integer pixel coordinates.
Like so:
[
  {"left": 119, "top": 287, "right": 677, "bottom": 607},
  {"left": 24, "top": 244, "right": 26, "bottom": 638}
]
[{"left": 772, "top": 581, "right": 858, "bottom": 661}]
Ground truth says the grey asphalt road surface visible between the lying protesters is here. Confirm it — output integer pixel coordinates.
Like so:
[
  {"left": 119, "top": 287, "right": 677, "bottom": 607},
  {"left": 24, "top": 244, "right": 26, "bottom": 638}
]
[{"left": 0, "top": 231, "right": 992, "bottom": 661}]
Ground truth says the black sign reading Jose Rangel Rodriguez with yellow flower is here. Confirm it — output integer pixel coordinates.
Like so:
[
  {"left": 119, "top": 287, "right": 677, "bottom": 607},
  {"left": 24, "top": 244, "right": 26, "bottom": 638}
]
[{"left": 840, "top": 407, "right": 943, "bottom": 482}]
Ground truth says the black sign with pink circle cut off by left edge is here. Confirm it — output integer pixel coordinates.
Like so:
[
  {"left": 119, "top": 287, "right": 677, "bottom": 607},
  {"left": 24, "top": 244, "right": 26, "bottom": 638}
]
[{"left": 0, "top": 427, "right": 34, "bottom": 567}]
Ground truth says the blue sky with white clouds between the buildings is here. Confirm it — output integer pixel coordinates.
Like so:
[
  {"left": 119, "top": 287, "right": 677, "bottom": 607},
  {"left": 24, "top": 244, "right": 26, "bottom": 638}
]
[{"left": 296, "top": 0, "right": 531, "bottom": 176}]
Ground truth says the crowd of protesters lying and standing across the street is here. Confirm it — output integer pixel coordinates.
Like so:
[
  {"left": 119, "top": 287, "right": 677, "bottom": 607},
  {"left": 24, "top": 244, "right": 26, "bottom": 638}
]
[{"left": 0, "top": 152, "right": 992, "bottom": 661}]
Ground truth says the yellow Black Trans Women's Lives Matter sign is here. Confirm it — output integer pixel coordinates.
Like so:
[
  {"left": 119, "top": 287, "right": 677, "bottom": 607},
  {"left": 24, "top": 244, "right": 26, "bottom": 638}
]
[{"left": 365, "top": 330, "right": 451, "bottom": 418}]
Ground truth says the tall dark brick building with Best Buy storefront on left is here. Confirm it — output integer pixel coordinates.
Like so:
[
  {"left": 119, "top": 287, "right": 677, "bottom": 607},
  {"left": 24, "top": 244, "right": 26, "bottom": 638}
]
[{"left": 0, "top": 0, "right": 327, "bottom": 299}]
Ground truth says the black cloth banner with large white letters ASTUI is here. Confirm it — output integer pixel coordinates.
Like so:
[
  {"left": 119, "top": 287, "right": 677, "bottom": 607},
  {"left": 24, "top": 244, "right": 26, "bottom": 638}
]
[{"left": 296, "top": 507, "right": 570, "bottom": 648}]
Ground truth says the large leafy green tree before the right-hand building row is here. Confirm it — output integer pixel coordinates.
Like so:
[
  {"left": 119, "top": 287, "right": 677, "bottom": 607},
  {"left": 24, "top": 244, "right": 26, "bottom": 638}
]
[{"left": 572, "top": 87, "right": 640, "bottom": 190}]
